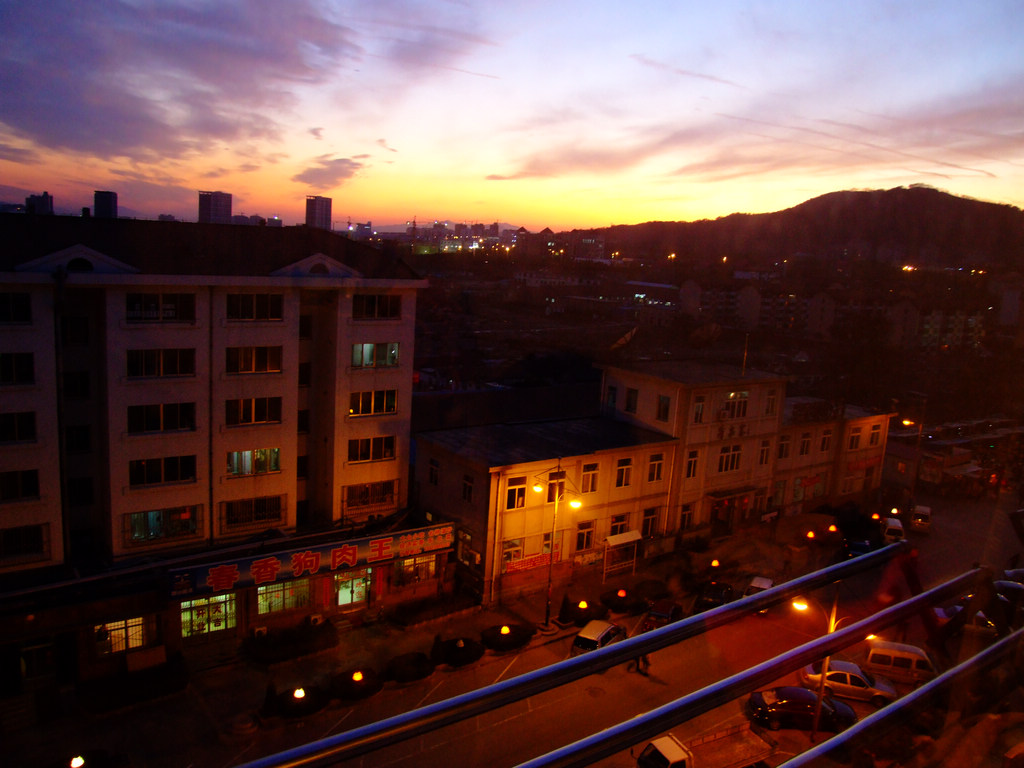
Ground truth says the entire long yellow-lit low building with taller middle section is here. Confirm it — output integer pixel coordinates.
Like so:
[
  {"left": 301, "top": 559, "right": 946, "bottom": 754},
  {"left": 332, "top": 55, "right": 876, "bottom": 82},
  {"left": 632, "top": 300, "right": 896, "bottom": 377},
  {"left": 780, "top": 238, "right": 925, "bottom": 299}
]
[{"left": 415, "top": 361, "right": 891, "bottom": 601}]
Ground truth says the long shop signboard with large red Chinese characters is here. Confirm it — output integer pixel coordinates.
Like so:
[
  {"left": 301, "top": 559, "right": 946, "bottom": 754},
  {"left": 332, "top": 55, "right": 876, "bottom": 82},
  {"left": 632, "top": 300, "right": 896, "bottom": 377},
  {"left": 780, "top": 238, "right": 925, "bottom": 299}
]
[{"left": 171, "top": 524, "right": 455, "bottom": 595}]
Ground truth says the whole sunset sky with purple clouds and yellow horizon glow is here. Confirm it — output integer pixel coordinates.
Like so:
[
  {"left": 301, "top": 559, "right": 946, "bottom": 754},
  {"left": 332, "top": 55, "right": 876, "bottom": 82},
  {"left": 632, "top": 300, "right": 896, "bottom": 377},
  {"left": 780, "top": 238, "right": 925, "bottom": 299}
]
[{"left": 0, "top": 0, "right": 1024, "bottom": 231}]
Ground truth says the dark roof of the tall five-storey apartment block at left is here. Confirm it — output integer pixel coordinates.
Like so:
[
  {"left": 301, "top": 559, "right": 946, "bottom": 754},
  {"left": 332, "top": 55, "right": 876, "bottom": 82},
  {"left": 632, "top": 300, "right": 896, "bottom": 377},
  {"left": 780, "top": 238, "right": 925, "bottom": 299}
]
[{"left": 0, "top": 213, "right": 421, "bottom": 280}]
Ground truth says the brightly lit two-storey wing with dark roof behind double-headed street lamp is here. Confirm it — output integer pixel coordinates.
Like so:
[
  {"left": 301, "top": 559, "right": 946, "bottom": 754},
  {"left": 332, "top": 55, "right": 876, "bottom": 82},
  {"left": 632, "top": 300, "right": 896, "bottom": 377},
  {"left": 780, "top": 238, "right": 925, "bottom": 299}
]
[{"left": 416, "top": 418, "right": 677, "bottom": 602}]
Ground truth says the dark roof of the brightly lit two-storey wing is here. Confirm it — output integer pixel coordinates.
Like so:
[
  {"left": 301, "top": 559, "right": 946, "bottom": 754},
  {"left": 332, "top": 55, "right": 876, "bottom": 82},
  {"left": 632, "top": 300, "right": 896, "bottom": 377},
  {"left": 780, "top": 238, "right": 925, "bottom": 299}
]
[{"left": 416, "top": 418, "right": 675, "bottom": 468}]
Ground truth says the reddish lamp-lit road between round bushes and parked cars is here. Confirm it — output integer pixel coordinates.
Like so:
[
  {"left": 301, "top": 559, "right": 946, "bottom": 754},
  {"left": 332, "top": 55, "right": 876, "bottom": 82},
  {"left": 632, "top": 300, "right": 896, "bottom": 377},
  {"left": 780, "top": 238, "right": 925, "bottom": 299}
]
[{"left": 315, "top": 495, "right": 1022, "bottom": 768}]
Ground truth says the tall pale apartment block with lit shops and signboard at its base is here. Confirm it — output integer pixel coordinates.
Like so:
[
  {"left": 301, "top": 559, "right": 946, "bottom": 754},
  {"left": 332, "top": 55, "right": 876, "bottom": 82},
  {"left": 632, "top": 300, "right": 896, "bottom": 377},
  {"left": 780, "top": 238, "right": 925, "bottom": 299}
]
[{"left": 0, "top": 214, "right": 443, "bottom": 692}]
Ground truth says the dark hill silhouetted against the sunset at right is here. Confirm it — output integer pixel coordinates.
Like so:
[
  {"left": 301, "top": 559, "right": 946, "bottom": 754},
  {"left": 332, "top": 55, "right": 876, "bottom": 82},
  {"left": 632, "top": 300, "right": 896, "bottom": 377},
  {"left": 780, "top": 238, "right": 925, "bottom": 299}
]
[{"left": 591, "top": 185, "right": 1024, "bottom": 271}]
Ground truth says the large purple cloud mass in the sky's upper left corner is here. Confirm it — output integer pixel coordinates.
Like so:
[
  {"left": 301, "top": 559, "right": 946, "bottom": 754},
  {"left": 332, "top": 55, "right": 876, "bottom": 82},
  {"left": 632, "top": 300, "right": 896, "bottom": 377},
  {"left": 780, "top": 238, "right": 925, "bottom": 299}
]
[{"left": 0, "top": 0, "right": 360, "bottom": 162}]
